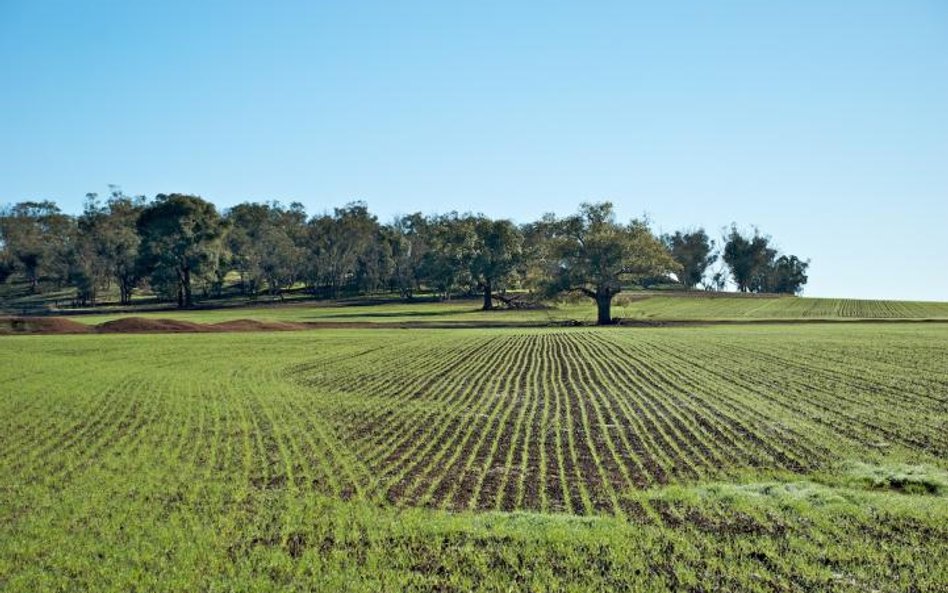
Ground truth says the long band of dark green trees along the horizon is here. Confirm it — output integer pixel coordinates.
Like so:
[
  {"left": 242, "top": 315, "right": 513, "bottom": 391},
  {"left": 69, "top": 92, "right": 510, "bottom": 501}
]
[{"left": 0, "top": 187, "right": 809, "bottom": 324}]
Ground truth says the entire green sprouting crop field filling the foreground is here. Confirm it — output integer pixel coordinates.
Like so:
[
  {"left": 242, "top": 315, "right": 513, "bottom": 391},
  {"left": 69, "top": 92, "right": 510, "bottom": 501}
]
[{"left": 0, "top": 324, "right": 948, "bottom": 592}]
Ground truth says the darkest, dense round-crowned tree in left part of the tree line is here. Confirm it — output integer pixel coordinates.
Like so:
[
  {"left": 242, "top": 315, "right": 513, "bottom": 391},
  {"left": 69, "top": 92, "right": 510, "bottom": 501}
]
[{"left": 138, "top": 194, "right": 225, "bottom": 307}]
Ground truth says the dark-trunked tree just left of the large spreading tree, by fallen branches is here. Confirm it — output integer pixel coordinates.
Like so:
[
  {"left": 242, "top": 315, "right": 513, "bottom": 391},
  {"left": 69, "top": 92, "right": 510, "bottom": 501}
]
[{"left": 469, "top": 216, "right": 523, "bottom": 311}]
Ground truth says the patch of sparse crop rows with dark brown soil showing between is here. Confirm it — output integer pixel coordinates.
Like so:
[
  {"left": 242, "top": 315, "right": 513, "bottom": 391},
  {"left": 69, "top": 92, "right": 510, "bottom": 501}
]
[{"left": 293, "top": 324, "right": 948, "bottom": 514}]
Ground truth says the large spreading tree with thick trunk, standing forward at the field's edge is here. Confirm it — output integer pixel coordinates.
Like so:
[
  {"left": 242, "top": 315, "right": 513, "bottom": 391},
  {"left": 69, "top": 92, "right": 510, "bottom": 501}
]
[{"left": 548, "top": 202, "right": 681, "bottom": 325}]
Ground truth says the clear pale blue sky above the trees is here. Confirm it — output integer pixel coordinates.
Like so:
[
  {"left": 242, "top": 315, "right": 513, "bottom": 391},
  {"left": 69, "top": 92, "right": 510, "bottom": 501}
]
[{"left": 0, "top": 0, "right": 948, "bottom": 300}]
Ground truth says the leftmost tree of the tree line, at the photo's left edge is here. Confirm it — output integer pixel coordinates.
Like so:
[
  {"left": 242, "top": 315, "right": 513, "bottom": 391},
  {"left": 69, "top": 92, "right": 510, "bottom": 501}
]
[{"left": 0, "top": 201, "right": 75, "bottom": 293}]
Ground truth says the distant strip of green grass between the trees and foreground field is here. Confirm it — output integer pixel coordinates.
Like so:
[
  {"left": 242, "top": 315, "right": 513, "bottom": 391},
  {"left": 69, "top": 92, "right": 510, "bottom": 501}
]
[{"left": 0, "top": 278, "right": 948, "bottom": 325}]
